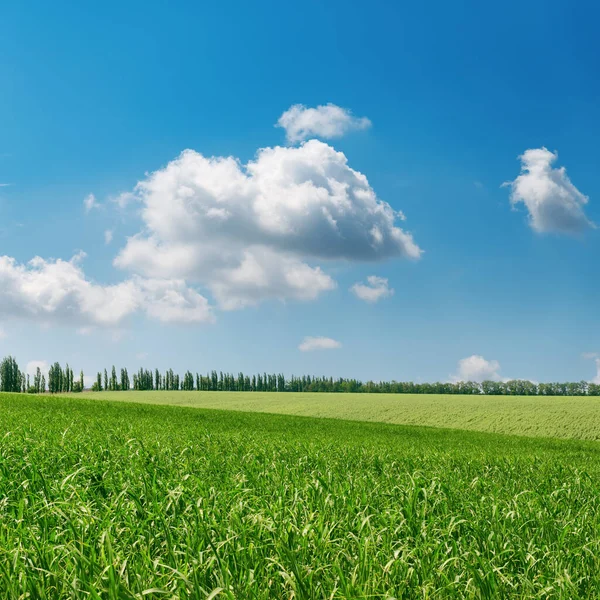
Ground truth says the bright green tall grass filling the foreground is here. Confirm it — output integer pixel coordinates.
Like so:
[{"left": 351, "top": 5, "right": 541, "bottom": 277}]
[{"left": 0, "top": 394, "right": 600, "bottom": 600}]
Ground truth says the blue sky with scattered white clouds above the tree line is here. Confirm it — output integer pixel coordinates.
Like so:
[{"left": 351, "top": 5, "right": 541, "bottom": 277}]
[{"left": 0, "top": 1, "right": 600, "bottom": 381}]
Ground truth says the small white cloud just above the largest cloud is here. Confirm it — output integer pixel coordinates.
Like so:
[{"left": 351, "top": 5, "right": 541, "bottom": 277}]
[{"left": 277, "top": 104, "right": 371, "bottom": 144}]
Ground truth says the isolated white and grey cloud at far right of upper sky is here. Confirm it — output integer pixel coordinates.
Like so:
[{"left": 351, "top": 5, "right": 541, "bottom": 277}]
[{"left": 504, "top": 148, "right": 594, "bottom": 234}]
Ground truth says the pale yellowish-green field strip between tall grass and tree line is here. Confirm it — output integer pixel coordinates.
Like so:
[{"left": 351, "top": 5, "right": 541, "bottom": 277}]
[{"left": 85, "top": 391, "right": 600, "bottom": 440}]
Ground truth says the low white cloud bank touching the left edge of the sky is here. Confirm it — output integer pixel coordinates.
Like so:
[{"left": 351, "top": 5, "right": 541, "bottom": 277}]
[{"left": 0, "top": 253, "right": 213, "bottom": 333}]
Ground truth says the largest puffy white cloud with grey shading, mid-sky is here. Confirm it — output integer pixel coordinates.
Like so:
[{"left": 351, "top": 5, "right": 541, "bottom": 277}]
[{"left": 115, "top": 140, "right": 421, "bottom": 309}]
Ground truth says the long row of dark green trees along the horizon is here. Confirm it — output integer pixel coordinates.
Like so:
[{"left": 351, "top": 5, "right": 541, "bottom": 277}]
[{"left": 0, "top": 356, "right": 600, "bottom": 396}]
